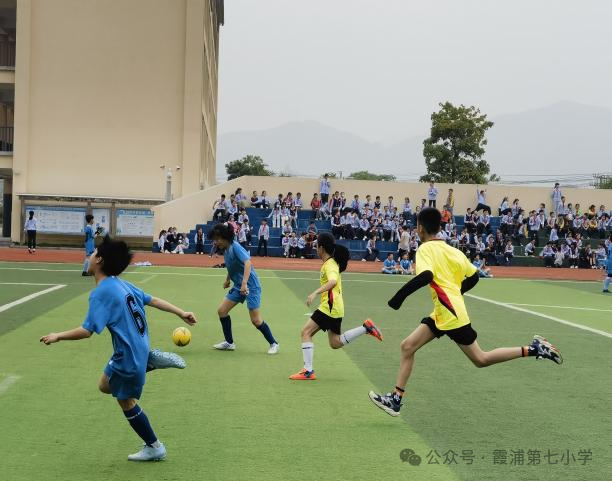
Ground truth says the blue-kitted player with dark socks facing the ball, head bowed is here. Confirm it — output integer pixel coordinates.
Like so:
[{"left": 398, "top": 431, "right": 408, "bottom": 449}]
[{"left": 208, "top": 224, "right": 279, "bottom": 354}]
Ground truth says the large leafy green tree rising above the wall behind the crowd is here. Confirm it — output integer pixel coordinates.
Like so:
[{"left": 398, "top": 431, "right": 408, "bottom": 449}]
[{"left": 420, "top": 102, "right": 499, "bottom": 184}]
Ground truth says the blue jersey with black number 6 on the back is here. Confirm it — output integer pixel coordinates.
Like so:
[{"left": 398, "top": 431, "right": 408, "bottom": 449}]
[{"left": 83, "top": 277, "right": 151, "bottom": 384}]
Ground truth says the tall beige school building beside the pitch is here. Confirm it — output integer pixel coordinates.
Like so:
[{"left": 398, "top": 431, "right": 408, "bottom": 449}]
[{"left": 0, "top": 0, "right": 224, "bottom": 241}]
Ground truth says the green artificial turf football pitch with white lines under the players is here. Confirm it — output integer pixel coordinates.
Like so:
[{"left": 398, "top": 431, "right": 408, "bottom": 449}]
[{"left": 0, "top": 263, "right": 612, "bottom": 481}]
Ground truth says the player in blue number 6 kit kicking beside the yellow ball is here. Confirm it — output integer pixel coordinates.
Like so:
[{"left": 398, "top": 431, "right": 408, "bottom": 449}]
[{"left": 40, "top": 236, "right": 196, "bottom": 461}]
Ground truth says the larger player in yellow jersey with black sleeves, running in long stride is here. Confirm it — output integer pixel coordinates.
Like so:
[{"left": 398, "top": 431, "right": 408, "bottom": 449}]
[{"left": 369, "top": 208, "right": 563, "bottom": 416}]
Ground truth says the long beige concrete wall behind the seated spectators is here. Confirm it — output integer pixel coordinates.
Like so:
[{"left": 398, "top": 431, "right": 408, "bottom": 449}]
[{"left": 154, "top": 176, "right": 612, "bottom": 231}]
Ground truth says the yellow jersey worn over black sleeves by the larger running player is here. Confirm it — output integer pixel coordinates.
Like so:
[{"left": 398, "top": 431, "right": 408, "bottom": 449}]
[{"left": 415, "top": 239, "right": 477, "bottom": 331}]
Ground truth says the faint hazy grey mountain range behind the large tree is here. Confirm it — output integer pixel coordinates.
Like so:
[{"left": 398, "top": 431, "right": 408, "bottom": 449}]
[{"left": 217, "top": 102, "right": 612, "bottom": 178}]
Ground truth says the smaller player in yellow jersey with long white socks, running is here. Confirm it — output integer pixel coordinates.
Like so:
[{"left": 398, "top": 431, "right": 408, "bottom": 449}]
[{"left": 289, "top": 233, "right": 383, "bottom": 381}]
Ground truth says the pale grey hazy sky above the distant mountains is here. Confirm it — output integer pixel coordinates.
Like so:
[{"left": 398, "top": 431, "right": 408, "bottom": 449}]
[{"left": 219, "top": 0, "right": 612, "bottom": 141}]
